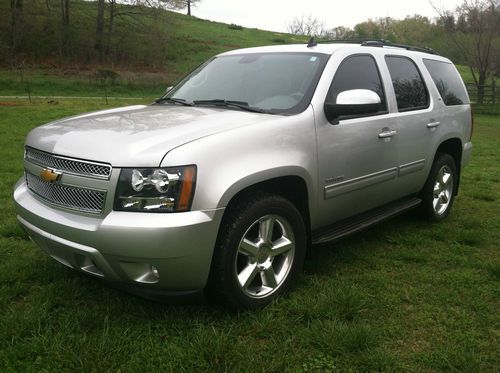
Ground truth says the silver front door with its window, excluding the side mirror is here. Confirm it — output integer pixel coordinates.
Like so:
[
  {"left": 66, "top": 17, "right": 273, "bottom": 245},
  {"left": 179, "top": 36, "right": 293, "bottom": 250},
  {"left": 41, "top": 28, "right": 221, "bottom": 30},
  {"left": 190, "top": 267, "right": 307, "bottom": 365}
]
[{"left": 316, "top": 54, "right": 398, "bottom": 225}]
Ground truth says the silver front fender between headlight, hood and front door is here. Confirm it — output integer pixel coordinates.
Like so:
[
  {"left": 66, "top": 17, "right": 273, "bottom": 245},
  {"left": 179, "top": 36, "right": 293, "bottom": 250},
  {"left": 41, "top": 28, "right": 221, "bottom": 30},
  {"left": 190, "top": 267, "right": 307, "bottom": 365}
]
[{"left": 162, "top": 107, "right": 317, "bottom": 217}]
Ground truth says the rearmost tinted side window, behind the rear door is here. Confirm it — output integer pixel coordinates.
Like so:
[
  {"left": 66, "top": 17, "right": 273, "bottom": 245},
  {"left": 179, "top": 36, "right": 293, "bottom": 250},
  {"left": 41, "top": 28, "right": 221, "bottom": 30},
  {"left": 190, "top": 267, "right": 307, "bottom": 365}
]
[{"left": 424, "top": 59, "right": 469, "bottom": 105}]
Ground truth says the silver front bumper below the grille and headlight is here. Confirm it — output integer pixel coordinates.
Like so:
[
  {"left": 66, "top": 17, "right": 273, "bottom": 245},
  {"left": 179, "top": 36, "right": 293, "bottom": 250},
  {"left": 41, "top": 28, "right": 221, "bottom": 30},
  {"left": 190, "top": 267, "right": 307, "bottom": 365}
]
[{"left": 14, "top": 179, "right": 224, "bottom": 293}]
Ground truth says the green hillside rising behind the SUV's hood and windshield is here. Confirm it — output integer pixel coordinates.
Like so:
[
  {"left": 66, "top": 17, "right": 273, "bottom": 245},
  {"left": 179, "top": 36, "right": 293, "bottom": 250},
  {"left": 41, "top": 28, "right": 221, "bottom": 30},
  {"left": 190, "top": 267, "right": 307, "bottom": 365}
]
[{"left": 0, "top": 1, "right": 307, "bottom": 98}]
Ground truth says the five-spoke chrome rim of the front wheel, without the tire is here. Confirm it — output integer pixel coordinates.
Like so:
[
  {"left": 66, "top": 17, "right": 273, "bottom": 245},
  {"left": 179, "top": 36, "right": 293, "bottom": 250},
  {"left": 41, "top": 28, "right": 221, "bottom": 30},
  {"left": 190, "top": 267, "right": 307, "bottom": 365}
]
[{"left": 234, "top": 215, "right": 295, "bottom": 298}]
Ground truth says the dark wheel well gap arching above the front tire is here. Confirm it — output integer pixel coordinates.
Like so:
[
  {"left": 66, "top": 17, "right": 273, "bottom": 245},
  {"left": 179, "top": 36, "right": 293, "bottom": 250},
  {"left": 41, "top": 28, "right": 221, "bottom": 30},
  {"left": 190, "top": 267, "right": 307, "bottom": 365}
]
[{"left": 226, "top": 176, "right": 311, "bottom": 237}]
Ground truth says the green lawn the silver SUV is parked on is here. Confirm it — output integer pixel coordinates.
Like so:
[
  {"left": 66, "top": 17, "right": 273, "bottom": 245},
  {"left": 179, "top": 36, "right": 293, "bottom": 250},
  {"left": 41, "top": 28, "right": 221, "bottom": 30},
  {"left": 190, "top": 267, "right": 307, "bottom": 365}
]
[{"left": 0, "top": 100, "right": 500, "bottom": 372}]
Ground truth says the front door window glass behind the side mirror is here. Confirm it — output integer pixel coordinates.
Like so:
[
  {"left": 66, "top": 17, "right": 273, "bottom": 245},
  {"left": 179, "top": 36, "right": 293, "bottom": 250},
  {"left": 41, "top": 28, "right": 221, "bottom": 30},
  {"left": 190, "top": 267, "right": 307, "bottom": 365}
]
[{"left": 328, "top": 54, "right": 387, "bottom": 114}]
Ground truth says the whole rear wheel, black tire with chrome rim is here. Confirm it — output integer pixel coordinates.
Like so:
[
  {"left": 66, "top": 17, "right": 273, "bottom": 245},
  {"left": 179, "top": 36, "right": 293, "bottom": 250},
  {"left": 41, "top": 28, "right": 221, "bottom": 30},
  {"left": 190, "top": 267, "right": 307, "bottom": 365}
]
[{"left": 421, "top": 153, "right": 458, "bottom": 220}]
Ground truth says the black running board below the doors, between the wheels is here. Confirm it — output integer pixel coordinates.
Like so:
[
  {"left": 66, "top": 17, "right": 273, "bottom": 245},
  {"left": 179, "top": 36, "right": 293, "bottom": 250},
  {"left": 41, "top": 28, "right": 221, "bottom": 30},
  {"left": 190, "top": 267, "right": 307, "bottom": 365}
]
[{"left": 312, "top": 198, "right": 422, "bottom": 244}]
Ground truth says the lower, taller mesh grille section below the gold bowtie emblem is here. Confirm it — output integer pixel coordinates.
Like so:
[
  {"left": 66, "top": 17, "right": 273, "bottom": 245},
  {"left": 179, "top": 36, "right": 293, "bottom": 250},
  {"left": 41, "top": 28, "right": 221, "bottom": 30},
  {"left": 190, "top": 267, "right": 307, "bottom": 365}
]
[{"left": 26, "top": 172, "right": 106, "bottom": 213}]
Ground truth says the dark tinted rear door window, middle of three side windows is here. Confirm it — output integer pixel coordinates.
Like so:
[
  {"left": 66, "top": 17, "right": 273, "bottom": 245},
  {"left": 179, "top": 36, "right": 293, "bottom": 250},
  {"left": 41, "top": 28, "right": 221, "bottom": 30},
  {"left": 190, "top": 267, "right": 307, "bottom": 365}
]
[{"left": 385, "top": 56, "right": 429, "bottom": 111}]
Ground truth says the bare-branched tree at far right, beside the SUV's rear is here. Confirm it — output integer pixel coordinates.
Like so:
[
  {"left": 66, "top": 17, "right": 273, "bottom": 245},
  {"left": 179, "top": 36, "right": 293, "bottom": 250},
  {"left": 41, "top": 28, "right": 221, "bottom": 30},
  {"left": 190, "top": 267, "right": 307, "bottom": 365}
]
[{"left": 436, "top": 0, "right": 500, "bottom": 104}]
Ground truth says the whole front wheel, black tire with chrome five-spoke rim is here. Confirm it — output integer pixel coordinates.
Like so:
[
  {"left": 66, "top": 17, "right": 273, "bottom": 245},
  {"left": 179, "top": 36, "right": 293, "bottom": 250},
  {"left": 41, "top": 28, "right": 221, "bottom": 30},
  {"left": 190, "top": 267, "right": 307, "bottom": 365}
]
[{"left": 207, "top": 194, "right": 307, "bottom": 310}]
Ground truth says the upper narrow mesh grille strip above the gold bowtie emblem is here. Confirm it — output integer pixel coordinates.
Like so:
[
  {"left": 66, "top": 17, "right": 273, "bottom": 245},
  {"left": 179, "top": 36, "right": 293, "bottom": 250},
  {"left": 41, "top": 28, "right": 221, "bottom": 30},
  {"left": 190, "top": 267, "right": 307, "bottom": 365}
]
[{"left": 25, "top": 147, "right": 111, "bottom": 179}]
